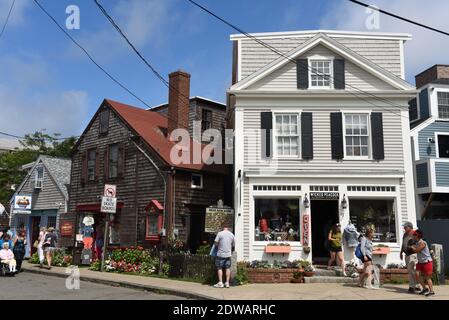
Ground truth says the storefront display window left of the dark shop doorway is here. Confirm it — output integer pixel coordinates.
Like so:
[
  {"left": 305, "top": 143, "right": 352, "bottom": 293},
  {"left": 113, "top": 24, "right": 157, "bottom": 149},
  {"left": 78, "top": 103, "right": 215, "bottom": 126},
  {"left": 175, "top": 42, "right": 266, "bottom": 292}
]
[{"left": 254, "top": 198, "right": 300, "bottom": 241}]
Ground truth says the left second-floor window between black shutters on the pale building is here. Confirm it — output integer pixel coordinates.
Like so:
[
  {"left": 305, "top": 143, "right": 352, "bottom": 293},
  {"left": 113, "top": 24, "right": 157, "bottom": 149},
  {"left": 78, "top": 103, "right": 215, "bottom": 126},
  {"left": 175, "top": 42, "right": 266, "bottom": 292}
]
[{"left": 275, "top": 114, "right": 299, "bottom": 157}]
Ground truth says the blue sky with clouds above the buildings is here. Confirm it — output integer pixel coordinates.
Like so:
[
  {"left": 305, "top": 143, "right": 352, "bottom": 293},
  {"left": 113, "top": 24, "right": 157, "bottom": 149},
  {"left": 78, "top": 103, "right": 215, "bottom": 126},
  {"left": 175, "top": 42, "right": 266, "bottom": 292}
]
[{"left": 0, "top": 0, "right": 449, "bottom": 135}]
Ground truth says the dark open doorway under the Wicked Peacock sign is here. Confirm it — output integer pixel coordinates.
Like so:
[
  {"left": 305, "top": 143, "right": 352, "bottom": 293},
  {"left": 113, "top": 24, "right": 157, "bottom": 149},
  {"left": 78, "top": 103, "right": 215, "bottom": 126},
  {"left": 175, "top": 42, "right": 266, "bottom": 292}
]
[{"left": 310, "top": 200, "right": 339, "bottom": 264}]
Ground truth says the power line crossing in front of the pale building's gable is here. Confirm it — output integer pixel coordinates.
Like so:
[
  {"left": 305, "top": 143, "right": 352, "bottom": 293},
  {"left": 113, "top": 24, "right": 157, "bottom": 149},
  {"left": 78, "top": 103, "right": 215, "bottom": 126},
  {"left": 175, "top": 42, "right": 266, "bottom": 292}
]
[{"left": 187, "top": 0, "right": 412, "bottom": 118}]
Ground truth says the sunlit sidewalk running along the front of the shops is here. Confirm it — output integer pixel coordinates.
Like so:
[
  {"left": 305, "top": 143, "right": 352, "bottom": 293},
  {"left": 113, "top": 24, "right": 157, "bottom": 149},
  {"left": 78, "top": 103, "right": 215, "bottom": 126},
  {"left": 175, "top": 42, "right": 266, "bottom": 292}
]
[{"left": 23, "top": 261, "right": 449, "bottom": 300}]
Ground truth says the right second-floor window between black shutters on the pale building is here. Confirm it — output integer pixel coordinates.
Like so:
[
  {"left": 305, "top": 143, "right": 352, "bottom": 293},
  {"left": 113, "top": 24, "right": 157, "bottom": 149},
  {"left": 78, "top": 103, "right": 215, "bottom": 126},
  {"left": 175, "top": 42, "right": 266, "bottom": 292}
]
[{"left": 345, "top": 114, "right": 369, "bottom": 158}]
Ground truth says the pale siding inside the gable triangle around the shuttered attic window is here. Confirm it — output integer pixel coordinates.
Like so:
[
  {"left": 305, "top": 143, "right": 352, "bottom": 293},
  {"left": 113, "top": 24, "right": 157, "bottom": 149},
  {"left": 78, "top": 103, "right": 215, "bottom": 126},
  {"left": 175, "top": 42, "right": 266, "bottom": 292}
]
[{"left": 248, "top": 45, "right": 394, "bottom": 91}]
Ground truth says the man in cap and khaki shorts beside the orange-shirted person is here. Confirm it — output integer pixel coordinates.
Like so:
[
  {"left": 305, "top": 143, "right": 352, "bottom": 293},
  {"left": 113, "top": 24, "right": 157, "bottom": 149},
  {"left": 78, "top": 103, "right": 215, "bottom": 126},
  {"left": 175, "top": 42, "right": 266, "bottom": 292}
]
[{"left": 400, "top": 221, "right": 421, "bottom": 293}]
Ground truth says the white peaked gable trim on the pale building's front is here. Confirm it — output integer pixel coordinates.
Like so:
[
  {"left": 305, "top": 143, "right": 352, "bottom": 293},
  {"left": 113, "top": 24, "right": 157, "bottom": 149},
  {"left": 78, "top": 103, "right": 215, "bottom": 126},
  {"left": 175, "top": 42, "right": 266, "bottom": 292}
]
[{"left": 229, "top": 33, "right": 415, "bottom": 91}]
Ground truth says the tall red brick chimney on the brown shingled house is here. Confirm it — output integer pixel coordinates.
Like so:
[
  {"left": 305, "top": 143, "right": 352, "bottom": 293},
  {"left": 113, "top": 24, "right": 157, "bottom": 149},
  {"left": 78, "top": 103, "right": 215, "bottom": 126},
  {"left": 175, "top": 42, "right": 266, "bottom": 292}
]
[{"left": 168, "top": 70, "right": 190, "bottom": 136}]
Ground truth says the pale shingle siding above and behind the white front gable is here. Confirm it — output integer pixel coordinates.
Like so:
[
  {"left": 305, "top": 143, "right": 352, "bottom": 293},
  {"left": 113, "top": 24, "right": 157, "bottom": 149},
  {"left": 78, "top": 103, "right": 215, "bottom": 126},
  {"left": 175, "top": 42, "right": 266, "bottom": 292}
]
[{"left": 239, "top": 36, "right": 401, "bottom": 79}]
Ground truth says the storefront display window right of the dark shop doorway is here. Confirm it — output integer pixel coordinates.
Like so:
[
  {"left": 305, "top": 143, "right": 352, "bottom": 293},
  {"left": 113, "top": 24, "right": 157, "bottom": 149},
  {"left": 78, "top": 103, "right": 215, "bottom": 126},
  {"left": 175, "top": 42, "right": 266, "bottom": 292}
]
[{"left": 349, "top": 199, "right": 397, "bottom": 242}]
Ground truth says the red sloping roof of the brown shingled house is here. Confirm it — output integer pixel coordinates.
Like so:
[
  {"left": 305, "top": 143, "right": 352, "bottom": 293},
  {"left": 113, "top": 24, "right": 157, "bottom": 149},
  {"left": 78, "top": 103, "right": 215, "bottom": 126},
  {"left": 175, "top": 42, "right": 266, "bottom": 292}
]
[{"left": 105, "top": 99, "right": 227, "bottom": 174}]
